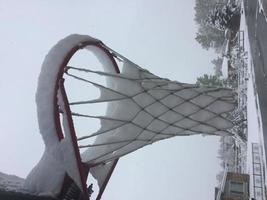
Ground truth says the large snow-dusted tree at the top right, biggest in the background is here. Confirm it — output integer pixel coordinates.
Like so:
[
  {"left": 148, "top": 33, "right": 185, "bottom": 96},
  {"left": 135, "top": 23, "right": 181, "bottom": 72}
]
[{"left": 194, "top": 0, "right": 238, "bottom": 52}]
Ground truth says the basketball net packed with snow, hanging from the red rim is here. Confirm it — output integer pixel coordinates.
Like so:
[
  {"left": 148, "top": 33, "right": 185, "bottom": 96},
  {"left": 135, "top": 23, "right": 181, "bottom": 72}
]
[{"left": 65, "top": 52, "right": 235, "bottom": 164}]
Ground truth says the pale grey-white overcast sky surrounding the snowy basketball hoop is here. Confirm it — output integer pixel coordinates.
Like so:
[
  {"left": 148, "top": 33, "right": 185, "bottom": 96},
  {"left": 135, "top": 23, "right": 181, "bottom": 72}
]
[{"left": 0, "top": 0, "right": 222, "bottom": 200}]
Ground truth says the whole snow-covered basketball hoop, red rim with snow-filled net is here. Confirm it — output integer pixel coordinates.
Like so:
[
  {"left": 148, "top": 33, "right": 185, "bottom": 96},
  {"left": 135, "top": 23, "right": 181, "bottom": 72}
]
[{"left": 32, "top": 34, "right": 238, "bottom": 196}]
